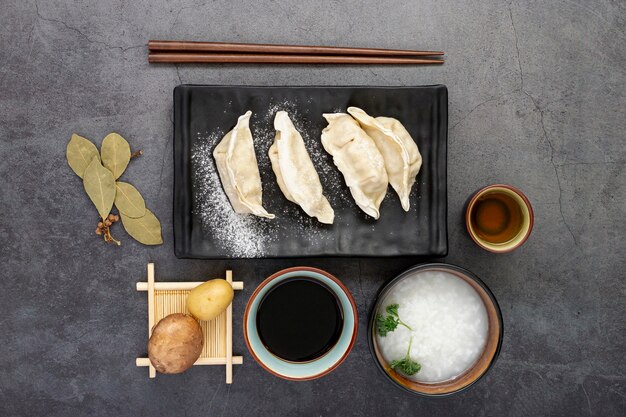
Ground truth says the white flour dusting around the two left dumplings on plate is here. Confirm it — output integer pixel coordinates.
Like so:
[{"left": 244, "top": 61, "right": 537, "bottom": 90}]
[{"left": 191, "top": 101, "right": 342, "bottom": 258}]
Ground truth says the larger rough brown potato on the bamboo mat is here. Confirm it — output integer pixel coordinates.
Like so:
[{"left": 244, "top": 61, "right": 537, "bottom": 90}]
[{"left": 148, "top": 313, "right": 204, "bottom": 374}]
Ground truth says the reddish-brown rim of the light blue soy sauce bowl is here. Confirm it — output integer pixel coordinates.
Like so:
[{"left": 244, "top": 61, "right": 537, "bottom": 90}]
[{"left": 243, "top": 266, "right": 359, "bottom": 381}]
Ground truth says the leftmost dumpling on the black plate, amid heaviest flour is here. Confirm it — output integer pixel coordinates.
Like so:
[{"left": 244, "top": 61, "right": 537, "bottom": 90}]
[{"left": 213, "top": 111, "right": 274, "bottom": 219}]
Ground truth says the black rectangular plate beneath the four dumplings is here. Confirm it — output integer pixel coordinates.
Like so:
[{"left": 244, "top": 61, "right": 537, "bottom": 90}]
[{"left": 174, "top": 85, "right": 448, "bottom": 259}]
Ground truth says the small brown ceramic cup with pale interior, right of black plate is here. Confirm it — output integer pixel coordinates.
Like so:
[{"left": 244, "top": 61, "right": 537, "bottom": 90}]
[{"left": 465, "top": 184, "right": 534, "bottom": 253}]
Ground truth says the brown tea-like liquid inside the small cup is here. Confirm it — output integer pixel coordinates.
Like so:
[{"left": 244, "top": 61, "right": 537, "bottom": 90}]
[{"left": 470, "top": 192, "right": 523, "bottom": 243}]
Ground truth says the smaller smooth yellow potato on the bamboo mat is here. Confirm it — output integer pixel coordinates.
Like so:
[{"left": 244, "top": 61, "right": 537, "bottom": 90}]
[{"left": 187, "top": 279, "right": 234, "bottom": 320}]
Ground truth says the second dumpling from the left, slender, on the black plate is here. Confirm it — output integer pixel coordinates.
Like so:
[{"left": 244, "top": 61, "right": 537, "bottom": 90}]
[{"left": 269, "top": 111, "right": 335, "bottom": 224}]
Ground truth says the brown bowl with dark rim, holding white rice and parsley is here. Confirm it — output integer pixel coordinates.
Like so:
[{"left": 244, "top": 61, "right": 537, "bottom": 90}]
[{"left": 367, "top": 263, "right": 503, "bottom": 397}]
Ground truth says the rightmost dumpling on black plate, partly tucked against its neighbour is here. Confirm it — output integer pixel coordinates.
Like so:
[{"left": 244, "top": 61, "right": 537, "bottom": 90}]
[{"left": 348, "top": 107, "right": 422, "bottom": 211}]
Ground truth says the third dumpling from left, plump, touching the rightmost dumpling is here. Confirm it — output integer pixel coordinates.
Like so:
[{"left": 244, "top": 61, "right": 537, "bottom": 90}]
[{"left": 322, "top": 113, "right": 389, "bottom": 219}]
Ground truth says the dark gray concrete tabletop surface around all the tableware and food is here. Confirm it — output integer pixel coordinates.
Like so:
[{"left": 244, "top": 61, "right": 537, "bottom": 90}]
[{"left": 0, "top": 0, "right": 626, "bottom": 416}]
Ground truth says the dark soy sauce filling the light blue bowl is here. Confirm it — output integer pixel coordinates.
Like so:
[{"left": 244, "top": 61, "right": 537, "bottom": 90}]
[{"left": 256, "top": 277, "right": 343, "bottom": 362}]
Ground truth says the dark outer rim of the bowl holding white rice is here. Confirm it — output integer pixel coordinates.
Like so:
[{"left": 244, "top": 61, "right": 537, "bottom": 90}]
[{"left": 367, "top": 262, "right": 504, "bottom": 398}]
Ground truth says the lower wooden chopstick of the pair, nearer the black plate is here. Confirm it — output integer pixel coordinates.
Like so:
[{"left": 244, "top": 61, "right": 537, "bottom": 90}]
[{"left": 148, "top": 52, "right": 444, "bottom": 65}]
